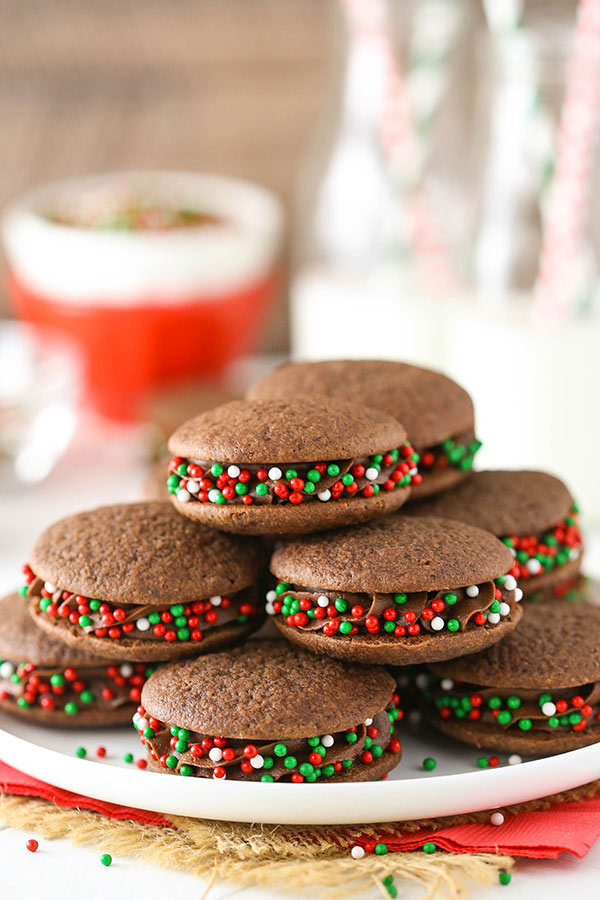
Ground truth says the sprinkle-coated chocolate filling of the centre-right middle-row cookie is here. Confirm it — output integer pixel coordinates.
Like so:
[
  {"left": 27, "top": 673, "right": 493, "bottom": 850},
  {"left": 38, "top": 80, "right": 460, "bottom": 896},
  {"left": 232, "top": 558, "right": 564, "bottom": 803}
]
[{"left": 265, "top": 575, "right": 522, "bottom": 637}]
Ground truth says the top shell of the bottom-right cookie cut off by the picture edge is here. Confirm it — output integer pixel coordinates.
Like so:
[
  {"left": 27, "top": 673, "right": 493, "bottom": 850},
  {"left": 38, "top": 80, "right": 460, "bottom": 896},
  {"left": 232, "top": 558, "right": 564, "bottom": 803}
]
[{"left": 431, "top": 600, "right": 600, "bottom": 691}]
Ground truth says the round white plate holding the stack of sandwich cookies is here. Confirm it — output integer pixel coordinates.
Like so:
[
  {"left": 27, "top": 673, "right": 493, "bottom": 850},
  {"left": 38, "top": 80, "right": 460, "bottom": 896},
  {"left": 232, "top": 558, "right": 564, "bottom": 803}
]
[{"left": 0, "top": 715, "right": 600, "bottom": 825}]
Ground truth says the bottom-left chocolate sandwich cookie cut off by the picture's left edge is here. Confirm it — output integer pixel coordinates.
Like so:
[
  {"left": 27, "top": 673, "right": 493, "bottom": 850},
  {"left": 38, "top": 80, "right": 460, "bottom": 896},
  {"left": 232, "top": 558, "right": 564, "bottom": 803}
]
[{"left": 0, "top": 594, "right": 156, "bottom": 727}]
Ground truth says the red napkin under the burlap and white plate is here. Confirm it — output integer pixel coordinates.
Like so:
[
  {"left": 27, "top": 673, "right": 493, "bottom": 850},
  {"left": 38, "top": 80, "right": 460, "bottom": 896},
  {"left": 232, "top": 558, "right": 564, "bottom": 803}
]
[{"left": 0, "top": 762, "right": 600, "bottom": 859}]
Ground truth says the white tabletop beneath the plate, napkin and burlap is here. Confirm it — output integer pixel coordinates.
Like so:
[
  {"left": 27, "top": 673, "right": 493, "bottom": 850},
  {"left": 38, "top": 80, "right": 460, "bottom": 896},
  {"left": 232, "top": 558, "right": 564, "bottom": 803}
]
[{"left": 0, "top": 429, "right": 600, "bottom": 900}]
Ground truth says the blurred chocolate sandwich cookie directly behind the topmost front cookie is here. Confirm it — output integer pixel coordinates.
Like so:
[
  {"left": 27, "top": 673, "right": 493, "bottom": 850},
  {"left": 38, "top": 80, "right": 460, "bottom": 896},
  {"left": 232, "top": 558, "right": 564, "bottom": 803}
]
[{"left": 248, "top": 359, "right": 481, "bottom": 499}]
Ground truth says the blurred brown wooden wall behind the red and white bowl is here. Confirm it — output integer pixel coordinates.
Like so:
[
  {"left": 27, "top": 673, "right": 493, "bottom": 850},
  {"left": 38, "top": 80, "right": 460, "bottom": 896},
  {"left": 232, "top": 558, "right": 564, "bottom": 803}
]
[{"left": 0, "top": 0, "right": 332, "bottom": 348}]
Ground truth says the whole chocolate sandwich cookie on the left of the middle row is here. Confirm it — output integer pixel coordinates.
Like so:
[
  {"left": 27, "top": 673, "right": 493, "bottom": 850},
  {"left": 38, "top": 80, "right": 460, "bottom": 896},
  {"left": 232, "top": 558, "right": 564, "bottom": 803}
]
[{"left": 23, "top": 502, "right": 264, "bottom": 661}]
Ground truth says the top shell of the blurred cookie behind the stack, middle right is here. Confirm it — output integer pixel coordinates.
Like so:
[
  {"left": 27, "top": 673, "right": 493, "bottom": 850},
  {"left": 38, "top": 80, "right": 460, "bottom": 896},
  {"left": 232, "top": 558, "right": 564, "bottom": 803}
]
[{"left": 407, "top": 470, "right": 573, "bottom": 536}]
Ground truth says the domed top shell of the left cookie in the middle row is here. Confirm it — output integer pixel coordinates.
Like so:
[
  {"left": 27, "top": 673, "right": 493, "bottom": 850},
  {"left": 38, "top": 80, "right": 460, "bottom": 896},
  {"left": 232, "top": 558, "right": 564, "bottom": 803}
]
[{"left": 30, "top": 501, "right": 264, "bottom": 605}]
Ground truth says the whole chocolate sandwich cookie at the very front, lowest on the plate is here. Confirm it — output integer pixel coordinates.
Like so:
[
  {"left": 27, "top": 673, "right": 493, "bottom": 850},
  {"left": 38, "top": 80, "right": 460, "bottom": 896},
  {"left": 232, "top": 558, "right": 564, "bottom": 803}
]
[{"left": 134, "top": 639, "right": 402, "bottom": 783}]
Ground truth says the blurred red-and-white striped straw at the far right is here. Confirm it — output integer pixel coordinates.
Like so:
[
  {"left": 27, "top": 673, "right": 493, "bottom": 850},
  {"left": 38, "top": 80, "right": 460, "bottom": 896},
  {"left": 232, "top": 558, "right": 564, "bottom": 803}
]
[{"left": 533, "top": 0, "right": 600, "bottom": 323}]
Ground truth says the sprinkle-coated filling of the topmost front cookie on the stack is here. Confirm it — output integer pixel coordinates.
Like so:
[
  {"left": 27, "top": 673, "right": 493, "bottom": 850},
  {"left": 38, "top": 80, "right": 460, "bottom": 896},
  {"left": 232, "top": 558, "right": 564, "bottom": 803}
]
[{"left": 167, "top": 442, "right": 422, "bottom": 506}]
